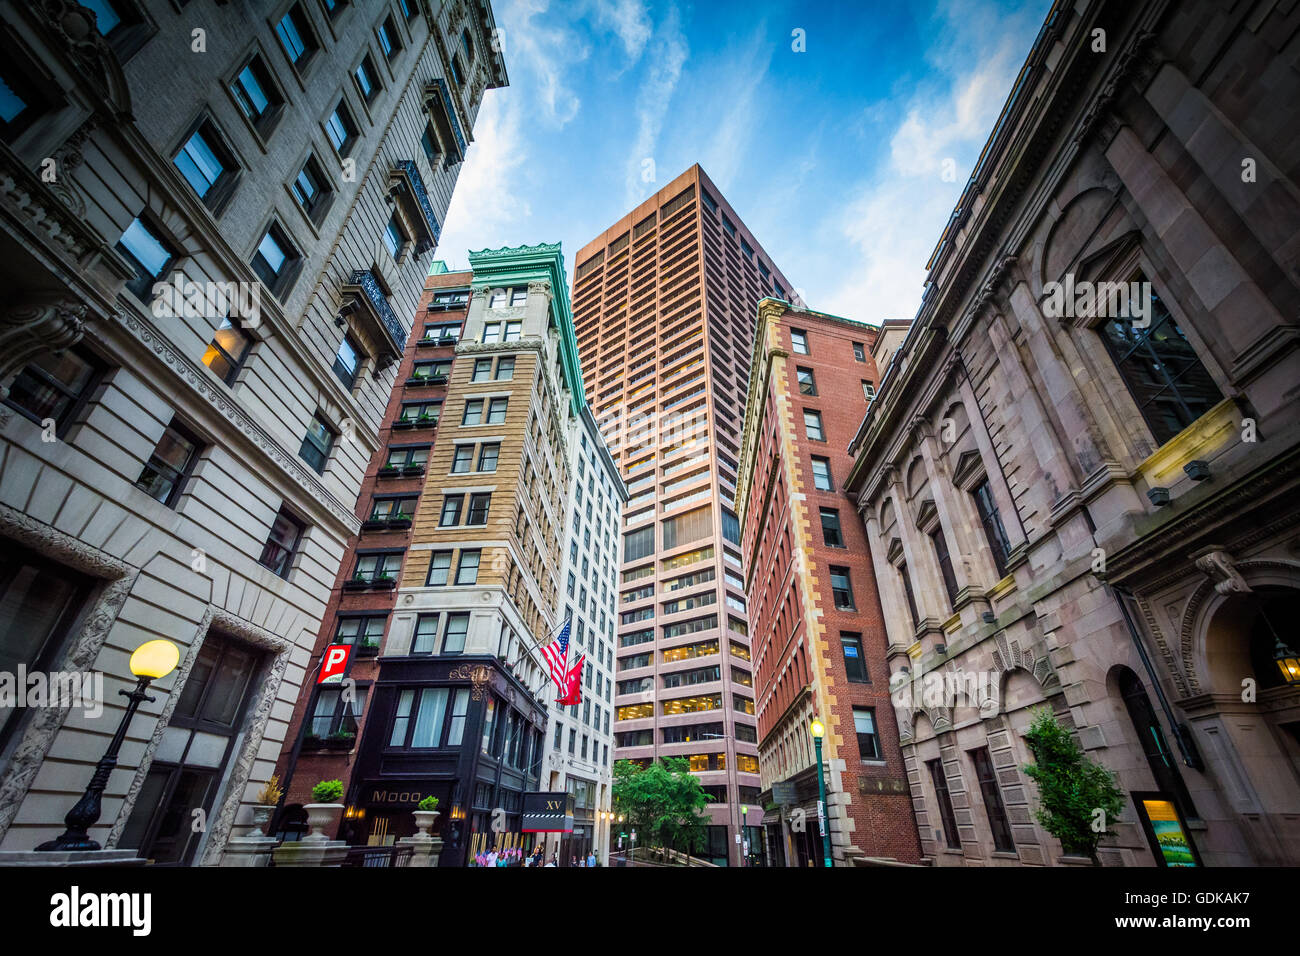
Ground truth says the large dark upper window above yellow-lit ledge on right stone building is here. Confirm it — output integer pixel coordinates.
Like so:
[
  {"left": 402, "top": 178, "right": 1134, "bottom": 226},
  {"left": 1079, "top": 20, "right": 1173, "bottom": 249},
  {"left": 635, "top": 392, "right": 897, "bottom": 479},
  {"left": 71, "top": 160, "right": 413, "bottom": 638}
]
[{"left": 1099, "top": 272, "right": 1223, "bottom": 445}]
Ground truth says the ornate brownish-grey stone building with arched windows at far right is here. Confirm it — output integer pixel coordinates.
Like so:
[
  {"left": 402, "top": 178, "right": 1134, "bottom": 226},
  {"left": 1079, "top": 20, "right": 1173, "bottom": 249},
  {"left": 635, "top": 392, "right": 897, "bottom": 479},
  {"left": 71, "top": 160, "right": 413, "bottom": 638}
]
[{"left": 848, "top": 0, "right": 1300, "bottom": 865}]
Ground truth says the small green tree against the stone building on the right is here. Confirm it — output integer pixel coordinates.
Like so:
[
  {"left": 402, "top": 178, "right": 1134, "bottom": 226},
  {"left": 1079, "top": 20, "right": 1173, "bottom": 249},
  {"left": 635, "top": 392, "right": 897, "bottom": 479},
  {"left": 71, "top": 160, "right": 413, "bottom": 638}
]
[{"left": 1024, "top": 708, "right": 1125, "bottom": 862}]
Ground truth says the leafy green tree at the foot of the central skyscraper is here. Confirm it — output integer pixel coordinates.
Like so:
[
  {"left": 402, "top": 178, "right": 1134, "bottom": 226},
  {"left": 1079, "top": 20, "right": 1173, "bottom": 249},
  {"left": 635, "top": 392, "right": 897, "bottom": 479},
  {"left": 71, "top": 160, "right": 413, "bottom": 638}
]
[{"left": 614, "top": 757, "right": 711, "bottom": 856}]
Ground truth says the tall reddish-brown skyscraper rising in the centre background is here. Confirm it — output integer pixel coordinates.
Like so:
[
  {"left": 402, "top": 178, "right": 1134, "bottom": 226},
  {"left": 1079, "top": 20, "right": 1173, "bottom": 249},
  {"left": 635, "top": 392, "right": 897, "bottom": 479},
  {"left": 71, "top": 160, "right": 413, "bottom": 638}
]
[{"left": 573, "top": 165, "right": 790, "bottom": 865}]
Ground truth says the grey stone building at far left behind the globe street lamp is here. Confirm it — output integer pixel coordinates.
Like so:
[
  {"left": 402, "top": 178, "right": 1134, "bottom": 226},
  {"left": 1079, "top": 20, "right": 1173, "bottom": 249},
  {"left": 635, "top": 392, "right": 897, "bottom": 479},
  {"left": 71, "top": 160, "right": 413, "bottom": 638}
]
[{"left": 0, "top": 0, "right": 506, "bottom": 864}]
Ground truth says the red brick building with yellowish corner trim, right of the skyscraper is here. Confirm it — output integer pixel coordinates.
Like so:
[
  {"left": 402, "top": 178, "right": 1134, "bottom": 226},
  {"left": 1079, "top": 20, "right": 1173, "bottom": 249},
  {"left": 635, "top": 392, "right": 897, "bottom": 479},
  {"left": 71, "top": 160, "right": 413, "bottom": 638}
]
[{"left": 737, "top": 299, "right": 920, "bottom": 866}]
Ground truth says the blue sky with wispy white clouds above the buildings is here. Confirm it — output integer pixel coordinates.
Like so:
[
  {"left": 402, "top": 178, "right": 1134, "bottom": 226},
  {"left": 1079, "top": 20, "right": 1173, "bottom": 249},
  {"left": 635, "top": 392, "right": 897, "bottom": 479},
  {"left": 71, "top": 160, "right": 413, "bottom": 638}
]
[{"left": 437, "top": 0, "right": 1050, "bottom": 323}]
